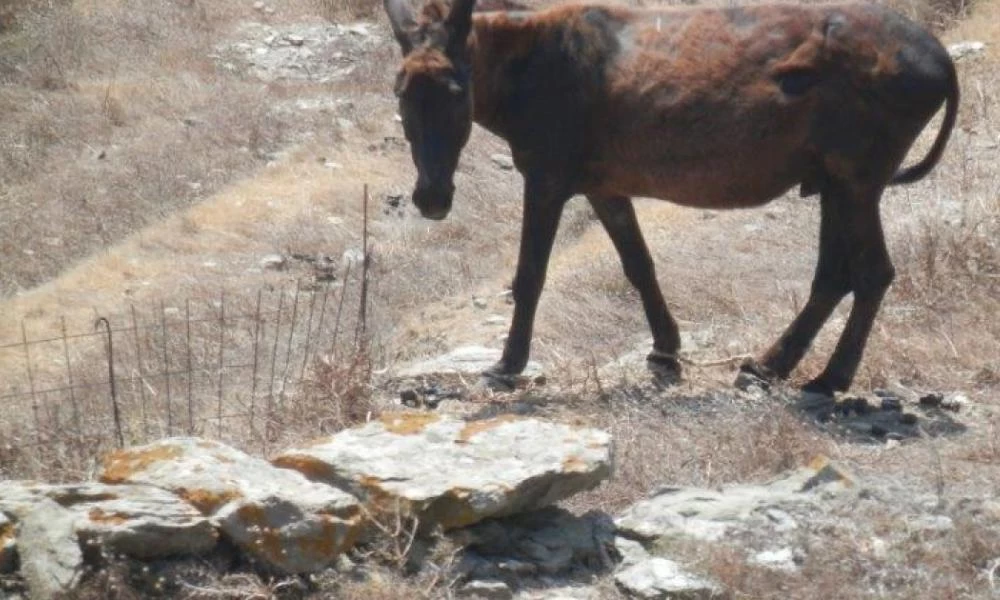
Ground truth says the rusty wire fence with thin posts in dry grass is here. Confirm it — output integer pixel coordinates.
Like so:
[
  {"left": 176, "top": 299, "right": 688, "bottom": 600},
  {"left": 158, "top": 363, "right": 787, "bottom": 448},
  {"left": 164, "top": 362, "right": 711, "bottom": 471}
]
[{"left": 0, "top": 188, "right": 373, "bottom": 475}]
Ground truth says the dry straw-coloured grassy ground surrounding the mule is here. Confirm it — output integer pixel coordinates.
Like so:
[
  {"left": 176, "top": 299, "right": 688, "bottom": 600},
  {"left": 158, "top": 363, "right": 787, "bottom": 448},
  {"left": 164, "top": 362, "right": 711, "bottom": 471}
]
[{"left": 0, "top": 0, "right": 1000, "bottom": 598}]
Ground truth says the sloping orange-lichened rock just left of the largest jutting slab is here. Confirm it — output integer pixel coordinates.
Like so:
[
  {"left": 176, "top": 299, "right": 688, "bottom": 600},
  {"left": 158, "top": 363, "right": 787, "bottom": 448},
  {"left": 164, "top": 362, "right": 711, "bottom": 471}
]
[{"left": 100, "top": 438, "right": 364, "bottom": 573}]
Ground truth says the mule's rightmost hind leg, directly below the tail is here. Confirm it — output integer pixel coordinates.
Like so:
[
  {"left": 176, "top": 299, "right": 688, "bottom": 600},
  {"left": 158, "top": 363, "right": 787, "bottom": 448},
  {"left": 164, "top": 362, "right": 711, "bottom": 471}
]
[{"left": 806, "top": 186, "right": 895, "bottom": 393}]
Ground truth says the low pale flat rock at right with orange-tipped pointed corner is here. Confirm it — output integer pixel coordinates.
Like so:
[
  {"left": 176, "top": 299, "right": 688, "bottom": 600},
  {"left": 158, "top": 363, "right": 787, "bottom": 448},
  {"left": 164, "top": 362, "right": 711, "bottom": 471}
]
[{"left": 615, "top": 457, "right": 855, "bottom": 541}]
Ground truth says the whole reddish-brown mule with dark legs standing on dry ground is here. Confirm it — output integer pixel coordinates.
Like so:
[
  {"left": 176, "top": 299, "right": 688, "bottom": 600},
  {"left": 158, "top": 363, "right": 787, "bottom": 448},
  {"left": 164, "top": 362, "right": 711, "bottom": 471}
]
[{"left": 385, "top": 0, "right": 959, "bottom": 392}]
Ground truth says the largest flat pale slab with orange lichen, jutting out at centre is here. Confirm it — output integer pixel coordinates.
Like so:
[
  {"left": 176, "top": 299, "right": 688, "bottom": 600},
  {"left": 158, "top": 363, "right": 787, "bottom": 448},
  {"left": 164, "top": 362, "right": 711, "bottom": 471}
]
[{"left": 273, "top": 412, "right": 612, "bottom": 529}]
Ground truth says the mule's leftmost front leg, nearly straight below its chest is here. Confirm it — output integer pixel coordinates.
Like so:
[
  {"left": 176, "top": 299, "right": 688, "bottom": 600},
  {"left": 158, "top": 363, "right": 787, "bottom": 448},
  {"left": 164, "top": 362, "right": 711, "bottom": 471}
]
[{"left": 486, "top": 176, "right": 569, "bottom": 375}]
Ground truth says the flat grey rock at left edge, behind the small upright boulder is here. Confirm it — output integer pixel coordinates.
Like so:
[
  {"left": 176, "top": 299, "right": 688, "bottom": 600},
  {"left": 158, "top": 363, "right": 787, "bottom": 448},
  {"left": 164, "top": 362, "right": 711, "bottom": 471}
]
[{"left": 0, "top": 481, "right": 218, "bottom": 560}]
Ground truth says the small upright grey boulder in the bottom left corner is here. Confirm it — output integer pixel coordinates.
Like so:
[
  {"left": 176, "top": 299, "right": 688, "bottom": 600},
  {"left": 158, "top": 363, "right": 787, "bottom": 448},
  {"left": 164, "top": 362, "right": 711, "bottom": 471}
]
[{"left": 17, "top": 498, "right": 83, "bottom": 600}]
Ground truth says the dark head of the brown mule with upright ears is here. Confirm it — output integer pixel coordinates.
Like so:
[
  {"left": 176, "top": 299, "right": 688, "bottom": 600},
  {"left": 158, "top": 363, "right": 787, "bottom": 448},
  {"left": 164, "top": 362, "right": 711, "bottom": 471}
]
[{"left": 384, "top": 0, "right": 475, "bottom": 220}]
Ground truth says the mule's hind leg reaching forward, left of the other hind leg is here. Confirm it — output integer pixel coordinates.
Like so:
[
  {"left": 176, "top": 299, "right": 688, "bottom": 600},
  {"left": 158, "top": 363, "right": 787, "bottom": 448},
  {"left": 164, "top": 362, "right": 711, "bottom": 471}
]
[{"left": 736, "top": 173, "right": 851, "bottom": 387}]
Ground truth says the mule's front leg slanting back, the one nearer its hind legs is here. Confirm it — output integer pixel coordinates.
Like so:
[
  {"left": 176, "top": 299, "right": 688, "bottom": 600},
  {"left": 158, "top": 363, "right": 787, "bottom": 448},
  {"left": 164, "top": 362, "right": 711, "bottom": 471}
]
[{"left": 587, "top": 196, "right": 681, "bottom": 378}]
